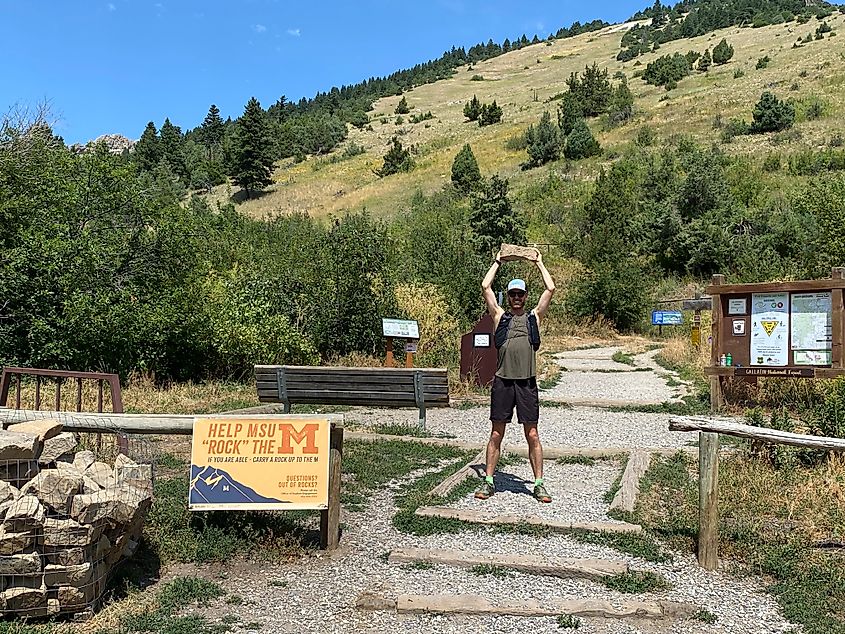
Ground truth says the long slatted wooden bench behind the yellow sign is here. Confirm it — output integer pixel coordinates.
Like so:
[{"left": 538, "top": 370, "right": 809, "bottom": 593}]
[{"left": 255, "top": 365, "right": 449, "bottom": 427}]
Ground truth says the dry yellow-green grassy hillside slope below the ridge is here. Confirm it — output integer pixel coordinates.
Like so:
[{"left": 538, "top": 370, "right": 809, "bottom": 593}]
[{"left": 204, "top": 14, "right": 845, "bottom": 217}]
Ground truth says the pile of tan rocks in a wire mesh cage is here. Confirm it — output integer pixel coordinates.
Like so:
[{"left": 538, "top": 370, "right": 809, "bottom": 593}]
[{"left": 0, "top": 421, "right": 155, "bottom": 617}]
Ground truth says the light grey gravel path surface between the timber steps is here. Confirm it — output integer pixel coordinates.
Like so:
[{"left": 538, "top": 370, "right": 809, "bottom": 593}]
[{"left": 172, "top": 348, "right": 800, "bottom": 634}]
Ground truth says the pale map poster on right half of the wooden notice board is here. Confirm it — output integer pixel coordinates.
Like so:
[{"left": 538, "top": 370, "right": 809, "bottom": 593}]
[{"left": 790, "top": 291, "right": 833, "bottom": 365}]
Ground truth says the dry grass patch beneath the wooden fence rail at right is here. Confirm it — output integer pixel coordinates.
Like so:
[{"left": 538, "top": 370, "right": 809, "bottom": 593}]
[{"left": 636, "top": 453, "right": 845, "bottom": 634}]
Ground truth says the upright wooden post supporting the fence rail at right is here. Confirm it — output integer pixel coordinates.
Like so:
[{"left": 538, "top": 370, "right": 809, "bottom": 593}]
[{"left": 698, "top": 432, "right": 719, "bottom": 570}]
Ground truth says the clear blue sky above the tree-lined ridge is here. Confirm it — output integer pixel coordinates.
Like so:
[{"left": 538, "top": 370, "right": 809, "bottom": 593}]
[{"left": 0, "top": 0, "right": 640, "bottom": 143}]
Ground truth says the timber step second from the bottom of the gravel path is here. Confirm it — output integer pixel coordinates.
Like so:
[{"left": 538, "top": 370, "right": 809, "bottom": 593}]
[{"left": 388, "top": 548, "right": 628, "bottom": 581}]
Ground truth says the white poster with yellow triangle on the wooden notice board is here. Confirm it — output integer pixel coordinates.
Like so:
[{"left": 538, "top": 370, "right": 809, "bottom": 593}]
[{"left": 751, "top": 293, "right": 789, "bottom": 366}]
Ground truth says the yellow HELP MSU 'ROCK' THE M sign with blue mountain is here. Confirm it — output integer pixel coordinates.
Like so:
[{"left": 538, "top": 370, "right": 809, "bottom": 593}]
[{"left": 188, "top": 415, "right": 331, "bottom": 511}]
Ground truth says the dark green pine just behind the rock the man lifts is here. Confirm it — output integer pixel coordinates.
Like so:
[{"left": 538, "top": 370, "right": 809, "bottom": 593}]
[{"left": 470, "top": 175, "right": 525, "bottom": 257}]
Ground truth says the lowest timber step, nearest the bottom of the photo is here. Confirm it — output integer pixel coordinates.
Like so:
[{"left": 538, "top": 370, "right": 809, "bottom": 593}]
[{"left": 356, "top": 592, "right": 698, "bottom": 621}]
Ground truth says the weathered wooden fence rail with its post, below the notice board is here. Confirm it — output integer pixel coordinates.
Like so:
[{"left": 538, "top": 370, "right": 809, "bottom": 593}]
[{"left": 669, "top": 416, "right": 845, "bottom": 570}]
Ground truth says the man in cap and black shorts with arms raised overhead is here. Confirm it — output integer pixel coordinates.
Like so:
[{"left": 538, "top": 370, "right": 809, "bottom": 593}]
[{"left": 475, "top": 251, "right": 555, "bottom": 502}]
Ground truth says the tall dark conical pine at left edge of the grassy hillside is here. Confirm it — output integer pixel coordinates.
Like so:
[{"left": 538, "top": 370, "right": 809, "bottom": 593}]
[{"left": 232, "top": 97, "right": 273, "bottom": 198}]
